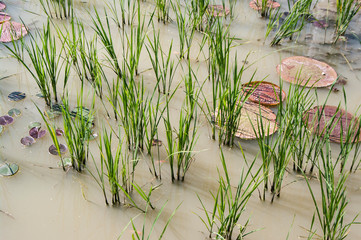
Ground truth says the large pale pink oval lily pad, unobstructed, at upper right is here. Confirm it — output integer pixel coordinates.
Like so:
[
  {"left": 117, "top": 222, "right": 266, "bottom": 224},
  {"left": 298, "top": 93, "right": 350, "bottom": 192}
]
[{"left": 276, "top": 56, "right": 337, "bottom": 87}]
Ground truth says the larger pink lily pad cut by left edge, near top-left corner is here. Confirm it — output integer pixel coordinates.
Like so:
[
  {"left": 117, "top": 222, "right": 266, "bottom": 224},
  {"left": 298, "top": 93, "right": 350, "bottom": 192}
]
[{"left": 0, "top": 22, "right": 28, "bottom": 42}]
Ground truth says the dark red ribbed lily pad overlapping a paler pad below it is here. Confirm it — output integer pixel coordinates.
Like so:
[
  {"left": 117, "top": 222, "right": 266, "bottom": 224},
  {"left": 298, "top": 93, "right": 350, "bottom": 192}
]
[{"left": 243, "top": 81, "right": 286, "bottom": 106}]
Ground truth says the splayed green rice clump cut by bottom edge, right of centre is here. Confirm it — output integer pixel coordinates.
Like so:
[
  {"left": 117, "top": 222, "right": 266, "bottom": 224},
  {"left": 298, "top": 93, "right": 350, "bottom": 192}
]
[{"left": 198, "top": 150, "right": 262, "bottom": 240}]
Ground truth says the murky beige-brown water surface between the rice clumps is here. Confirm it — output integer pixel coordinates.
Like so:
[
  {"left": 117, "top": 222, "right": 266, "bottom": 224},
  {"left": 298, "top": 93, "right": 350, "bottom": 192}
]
[{"left": 0, "top": 0, "right": 361, "bottom": 240}]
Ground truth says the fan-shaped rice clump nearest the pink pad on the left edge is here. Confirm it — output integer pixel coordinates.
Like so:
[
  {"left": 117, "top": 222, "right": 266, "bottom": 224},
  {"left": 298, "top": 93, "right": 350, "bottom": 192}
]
[{"left": 6, "top": 19, "right": 70, "bottom": 106}]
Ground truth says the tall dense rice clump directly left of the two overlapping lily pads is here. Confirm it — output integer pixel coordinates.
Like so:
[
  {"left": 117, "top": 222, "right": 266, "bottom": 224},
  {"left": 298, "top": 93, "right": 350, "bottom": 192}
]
[{"left": 203, "top": 20, "right": 255, "bottom": 146}]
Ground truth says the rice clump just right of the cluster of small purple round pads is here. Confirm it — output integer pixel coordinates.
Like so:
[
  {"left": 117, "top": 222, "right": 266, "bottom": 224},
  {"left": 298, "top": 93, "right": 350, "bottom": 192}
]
[{"left": 61, "top": 88, "right": 94, "bottom": 172}]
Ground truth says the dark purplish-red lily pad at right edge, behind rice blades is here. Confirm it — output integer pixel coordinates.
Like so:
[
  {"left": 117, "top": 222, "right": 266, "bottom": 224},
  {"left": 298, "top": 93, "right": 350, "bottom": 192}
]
[{"left": 303, "top": 105, "right": 359, "bottom": 143}]
